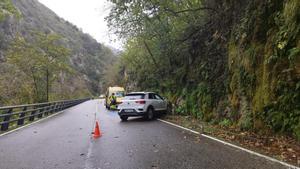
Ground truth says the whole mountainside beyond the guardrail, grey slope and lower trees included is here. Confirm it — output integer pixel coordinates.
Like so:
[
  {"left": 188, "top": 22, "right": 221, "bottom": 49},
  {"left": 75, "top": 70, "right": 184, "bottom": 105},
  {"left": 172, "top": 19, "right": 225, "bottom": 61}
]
[{"left": 0, "top": 0, "right": 115, "bottom": 106}]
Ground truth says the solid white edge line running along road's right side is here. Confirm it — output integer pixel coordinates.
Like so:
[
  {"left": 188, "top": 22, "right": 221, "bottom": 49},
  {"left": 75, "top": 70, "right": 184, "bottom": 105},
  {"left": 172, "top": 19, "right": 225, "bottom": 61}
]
[{"left": 157, "top": 119, "right": 300, "bottom": 169}]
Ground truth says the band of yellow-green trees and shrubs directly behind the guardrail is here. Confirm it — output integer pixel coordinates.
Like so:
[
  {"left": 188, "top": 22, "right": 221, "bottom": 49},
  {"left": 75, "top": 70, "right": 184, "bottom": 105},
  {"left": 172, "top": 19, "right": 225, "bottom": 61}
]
[{"left": 0, "top": 32, "right": 90, "bottom": 104}]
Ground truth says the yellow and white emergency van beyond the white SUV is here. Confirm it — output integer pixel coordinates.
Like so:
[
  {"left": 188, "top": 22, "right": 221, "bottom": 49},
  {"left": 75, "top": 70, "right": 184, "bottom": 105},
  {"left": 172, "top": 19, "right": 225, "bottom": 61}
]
[{"left": 105, "top": 86, "right": 125, "bottom": 110}]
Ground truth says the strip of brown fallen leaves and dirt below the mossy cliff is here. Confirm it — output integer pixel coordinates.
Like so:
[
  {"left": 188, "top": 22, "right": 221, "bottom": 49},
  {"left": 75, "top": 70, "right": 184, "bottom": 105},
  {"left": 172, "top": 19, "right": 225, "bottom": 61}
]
[{"left": 163, "top": 115, "right": 300, "bottom": 167}]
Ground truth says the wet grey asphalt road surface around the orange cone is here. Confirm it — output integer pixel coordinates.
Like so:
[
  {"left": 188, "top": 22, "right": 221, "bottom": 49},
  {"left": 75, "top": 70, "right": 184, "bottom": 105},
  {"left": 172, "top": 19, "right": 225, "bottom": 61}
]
[{"left": 0, "top": 100, "right": 285, "bottom": 169}]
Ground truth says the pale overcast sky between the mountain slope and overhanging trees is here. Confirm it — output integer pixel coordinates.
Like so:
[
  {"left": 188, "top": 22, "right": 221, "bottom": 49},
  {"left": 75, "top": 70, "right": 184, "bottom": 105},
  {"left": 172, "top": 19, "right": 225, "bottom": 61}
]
[{"left": 39, "top": 0, "right": 122, "bottom": 49}]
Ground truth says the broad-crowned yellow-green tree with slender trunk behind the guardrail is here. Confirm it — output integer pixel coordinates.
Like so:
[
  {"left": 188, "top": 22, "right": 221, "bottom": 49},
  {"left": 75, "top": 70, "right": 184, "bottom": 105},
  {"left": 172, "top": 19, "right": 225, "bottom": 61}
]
[{"left": 7, "top": 33, "right": 70, "bottom": 102}]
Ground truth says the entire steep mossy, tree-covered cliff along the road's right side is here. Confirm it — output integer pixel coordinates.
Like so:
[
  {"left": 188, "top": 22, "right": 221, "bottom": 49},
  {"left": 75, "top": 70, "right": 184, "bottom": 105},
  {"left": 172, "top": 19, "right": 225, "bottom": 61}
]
[{"left": 106, "top": 0, "right": 300, "bottom": 140}]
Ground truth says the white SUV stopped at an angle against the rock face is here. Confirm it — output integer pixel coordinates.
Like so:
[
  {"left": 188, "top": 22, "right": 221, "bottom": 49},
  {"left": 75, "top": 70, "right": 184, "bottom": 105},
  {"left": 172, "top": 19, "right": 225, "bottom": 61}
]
[{"left": 118, "top": 92, "right": 168, "bottom": 121}]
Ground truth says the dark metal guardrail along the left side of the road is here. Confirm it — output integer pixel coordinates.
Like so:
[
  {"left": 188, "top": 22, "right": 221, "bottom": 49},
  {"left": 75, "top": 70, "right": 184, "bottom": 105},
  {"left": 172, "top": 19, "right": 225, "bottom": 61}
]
[{"left": 0, "top": 99, "right": 90, "bottom": 132}]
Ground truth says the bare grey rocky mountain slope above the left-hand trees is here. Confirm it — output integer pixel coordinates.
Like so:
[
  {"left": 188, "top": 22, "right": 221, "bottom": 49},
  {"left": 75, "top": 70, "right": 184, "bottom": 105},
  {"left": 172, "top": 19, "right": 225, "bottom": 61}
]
[{"left": 0, "top": 0, "right": 114, "bottom": 93}]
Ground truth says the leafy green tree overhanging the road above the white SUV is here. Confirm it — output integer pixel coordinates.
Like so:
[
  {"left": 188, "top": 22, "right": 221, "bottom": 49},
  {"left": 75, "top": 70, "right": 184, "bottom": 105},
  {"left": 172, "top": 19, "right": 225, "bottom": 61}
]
[{"left": 106, "top": 0, "right": 214, "bottom": 88}]
